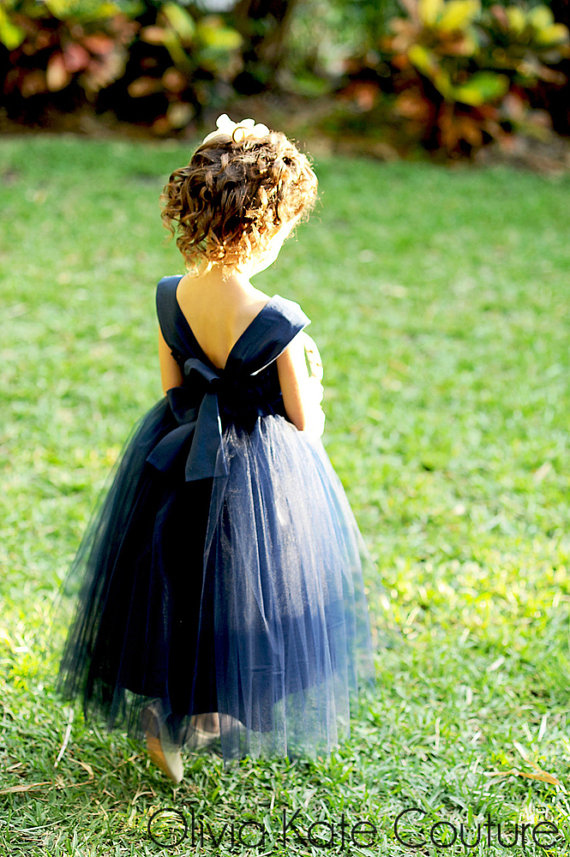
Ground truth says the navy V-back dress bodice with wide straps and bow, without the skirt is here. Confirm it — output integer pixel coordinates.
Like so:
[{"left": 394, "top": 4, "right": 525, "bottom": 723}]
[{"left": 147, "top": 276, "right": 310, "bottom": 480}]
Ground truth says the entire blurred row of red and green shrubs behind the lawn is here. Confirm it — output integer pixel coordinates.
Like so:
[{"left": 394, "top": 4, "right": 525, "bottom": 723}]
[{"left": 0, "top": 0, "right": 570, "bottom": 156}]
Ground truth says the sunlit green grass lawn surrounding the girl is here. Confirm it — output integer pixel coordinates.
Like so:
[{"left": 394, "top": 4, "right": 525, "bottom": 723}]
[{"left": 0, "top": 137, "right": 570, "bottom": 857}]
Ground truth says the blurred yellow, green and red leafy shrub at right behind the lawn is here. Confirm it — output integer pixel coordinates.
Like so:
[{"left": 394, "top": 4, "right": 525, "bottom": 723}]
[{"left": 338, "top": 0, "right": 570, "bottom": 155}]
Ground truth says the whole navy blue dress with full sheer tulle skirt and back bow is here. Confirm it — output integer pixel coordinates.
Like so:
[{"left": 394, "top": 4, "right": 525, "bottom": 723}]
[{"left": 53, "top": 276, "right": 373, "bottom": 759}]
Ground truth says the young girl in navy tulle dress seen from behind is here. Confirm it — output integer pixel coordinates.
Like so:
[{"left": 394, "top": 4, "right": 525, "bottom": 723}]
[{"left": 53, "top": 114, "right": 373, "bottom": 782}]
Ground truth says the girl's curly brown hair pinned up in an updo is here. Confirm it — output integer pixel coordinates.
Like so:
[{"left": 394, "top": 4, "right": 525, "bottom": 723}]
[{"left": 161, "top": 131, "right": 317, "bottom": 267}]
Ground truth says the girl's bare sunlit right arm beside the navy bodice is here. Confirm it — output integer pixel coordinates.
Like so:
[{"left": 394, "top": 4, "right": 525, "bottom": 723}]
[{"left": 277, "top": 332, "right": 325, "bottom": 437}]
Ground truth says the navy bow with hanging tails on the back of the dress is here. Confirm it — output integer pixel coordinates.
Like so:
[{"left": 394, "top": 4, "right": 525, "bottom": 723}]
[{"left": 146, "top": 357, "right": 228, "bottom": 482}]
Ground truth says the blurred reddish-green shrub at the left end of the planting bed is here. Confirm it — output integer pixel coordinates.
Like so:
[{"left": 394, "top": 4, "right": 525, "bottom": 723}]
[{"left": 0, "top": 0, "right": 242, "bottom": 134}]
